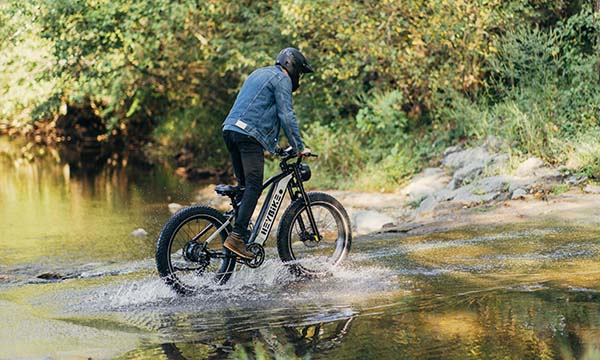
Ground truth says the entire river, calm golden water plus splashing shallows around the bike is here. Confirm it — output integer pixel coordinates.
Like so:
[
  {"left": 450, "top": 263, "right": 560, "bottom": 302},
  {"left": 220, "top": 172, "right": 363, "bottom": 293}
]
[{"left": 0, "top": 139, "right": 600, "bottom": 359}]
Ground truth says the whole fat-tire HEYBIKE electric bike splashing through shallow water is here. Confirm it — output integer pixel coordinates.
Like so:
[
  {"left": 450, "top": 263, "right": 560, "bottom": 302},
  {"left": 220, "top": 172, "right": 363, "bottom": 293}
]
[{"left": 156, "top": 148, "right": 352, "bottom": 295}]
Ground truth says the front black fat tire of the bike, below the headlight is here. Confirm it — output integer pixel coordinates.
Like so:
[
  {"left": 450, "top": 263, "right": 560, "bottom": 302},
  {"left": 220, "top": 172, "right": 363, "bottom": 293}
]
[{"left": 277, "top": 192, "right": 352, "bottom": 277}]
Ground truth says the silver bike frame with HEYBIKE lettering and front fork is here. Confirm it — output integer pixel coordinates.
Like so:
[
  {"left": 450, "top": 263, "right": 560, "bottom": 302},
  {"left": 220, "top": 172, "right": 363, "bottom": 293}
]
[{"left": 198, "top": 160, "right": 321, "bottom": 250}]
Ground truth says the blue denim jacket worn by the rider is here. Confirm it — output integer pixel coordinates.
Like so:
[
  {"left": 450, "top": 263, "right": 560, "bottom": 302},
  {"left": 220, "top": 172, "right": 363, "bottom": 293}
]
[{"left": 223, "top": 66, "right": 304, "bottom": 153}]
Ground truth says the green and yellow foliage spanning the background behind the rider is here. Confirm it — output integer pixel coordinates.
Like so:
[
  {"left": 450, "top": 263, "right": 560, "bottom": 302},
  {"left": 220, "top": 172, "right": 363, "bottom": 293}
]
[{"left": 0, "top": 0, "right": 600, "bottom": 190}]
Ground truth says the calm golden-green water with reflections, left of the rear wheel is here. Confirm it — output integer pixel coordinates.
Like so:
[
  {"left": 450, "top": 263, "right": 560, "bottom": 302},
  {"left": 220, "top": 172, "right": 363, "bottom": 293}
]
[{"left": 0, "top": 139, "right": 198, "bottom": 264}]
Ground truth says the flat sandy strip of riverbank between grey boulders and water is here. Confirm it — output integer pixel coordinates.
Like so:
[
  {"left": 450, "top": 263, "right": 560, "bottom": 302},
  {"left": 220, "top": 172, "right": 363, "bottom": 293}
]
[{"left": 331, "top": 189, "right": 600, "bottom": 238}]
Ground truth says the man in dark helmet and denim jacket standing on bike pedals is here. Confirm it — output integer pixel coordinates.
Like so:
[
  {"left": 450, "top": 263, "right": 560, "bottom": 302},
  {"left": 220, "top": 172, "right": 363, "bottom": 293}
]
[{"left": 223, "top": 48, "right": 313, "bottom": 259}]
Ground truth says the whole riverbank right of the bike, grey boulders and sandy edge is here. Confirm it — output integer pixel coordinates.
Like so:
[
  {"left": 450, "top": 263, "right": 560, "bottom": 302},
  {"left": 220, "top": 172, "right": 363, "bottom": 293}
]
[{"left": 331, "top": 138, "right": 600, "bottom": 237}]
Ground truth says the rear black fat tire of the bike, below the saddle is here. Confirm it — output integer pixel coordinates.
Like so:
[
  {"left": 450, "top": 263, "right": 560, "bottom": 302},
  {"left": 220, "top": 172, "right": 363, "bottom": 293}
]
[{"left": 156, "top": 206, "right": 235, "bottom": 295}]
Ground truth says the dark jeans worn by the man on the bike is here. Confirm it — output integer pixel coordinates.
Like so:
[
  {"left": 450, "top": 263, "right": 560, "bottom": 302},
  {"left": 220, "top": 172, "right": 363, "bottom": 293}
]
[{"left": 223, "top": 130, "right": 265, "bottom": 237}]
